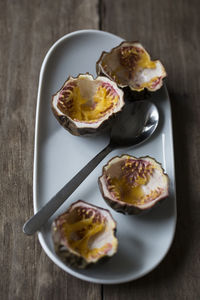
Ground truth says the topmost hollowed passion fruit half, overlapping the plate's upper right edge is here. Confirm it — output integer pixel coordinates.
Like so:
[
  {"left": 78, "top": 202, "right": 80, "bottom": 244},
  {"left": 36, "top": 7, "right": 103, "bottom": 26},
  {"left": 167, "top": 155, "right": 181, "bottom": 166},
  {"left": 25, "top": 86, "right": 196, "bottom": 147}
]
[{"left": 96, "top": 41, "right": 167, "bottom": 92}]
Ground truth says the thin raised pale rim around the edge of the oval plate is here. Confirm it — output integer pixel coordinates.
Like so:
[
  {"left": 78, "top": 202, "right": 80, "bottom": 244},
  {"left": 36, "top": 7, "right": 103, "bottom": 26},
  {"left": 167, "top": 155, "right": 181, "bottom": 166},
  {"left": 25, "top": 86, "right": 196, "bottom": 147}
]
[{"left": 33, "top": 29, "right": 177, "bottom": 284}]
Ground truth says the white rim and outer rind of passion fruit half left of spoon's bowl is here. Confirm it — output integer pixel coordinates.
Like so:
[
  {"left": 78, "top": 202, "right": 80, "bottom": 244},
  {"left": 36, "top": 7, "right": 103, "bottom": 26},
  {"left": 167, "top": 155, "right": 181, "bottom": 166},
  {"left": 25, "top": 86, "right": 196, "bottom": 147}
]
[{"left": 51, "top": 73, "right": 125, "bottom": 136}]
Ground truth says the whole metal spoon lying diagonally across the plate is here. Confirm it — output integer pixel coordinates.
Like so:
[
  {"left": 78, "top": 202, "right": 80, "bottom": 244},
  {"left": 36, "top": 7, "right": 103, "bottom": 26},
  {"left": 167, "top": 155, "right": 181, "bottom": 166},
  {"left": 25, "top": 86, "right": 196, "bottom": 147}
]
[{"left": 23, "top": 101, "right": 159, "bottom": 235}]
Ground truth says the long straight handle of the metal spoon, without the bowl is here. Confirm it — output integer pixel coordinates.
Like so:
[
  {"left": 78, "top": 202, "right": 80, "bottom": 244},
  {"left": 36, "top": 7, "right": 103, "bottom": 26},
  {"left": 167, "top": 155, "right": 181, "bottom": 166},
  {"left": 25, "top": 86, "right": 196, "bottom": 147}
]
[{"left": 23, "top": 144, "right": 113, "bottom": 235}]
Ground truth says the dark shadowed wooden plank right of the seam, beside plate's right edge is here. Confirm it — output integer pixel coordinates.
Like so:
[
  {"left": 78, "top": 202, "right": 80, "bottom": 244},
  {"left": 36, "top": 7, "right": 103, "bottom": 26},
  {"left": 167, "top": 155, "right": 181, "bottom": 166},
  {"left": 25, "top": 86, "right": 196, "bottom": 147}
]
[{"left": 101, "top": 0, "right": 200, "bottom": 300}]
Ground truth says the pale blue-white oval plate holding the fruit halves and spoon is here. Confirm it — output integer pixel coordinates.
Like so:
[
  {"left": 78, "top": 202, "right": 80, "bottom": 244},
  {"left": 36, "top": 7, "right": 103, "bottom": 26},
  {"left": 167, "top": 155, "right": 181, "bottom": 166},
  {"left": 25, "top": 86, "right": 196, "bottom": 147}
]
[{"left": 33, "top": 30, "right": 176, "bottom": 284}]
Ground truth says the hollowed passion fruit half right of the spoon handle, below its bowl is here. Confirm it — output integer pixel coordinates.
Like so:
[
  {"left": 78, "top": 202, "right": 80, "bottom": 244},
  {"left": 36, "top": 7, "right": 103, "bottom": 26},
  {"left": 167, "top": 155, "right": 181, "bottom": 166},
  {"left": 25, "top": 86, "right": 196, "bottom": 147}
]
[{"left": 99, "top": 155, "right": 169, "bottom": 214}]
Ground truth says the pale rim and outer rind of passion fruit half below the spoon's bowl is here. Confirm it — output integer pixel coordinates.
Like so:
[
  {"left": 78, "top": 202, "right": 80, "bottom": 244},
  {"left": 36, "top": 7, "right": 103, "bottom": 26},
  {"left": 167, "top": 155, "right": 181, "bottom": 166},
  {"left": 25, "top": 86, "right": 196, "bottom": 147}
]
[{"left": 98, "top": 154, "right": 169, "bottom": 215}]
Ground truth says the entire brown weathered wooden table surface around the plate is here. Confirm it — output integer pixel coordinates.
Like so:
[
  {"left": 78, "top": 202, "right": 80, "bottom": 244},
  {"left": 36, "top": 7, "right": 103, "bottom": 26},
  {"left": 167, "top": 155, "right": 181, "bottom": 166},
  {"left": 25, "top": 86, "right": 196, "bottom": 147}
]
[{"left": 0, "top": 0, "right": 200, "bottom": 300}]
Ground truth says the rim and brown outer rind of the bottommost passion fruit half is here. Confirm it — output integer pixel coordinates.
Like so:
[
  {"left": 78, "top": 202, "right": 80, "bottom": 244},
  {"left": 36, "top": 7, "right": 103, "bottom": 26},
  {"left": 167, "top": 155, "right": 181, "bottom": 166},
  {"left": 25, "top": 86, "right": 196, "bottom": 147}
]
[{"left": 51, "top": 200, "right": 117, "bottom": 269}]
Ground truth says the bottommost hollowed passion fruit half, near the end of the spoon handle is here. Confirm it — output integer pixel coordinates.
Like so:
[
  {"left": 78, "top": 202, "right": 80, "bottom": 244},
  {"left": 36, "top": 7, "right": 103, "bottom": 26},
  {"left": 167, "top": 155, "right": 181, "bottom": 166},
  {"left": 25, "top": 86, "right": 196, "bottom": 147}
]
[{"left": 52, "top": 200, "right": 118, "bottom": 268}]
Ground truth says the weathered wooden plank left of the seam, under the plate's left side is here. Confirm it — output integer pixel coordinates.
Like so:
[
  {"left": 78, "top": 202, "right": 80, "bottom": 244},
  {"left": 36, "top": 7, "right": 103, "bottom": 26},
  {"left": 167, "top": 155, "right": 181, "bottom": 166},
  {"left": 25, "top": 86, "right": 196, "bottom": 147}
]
[{"left": 0, "top": 0, "right": 101, "bottom": 300}]
